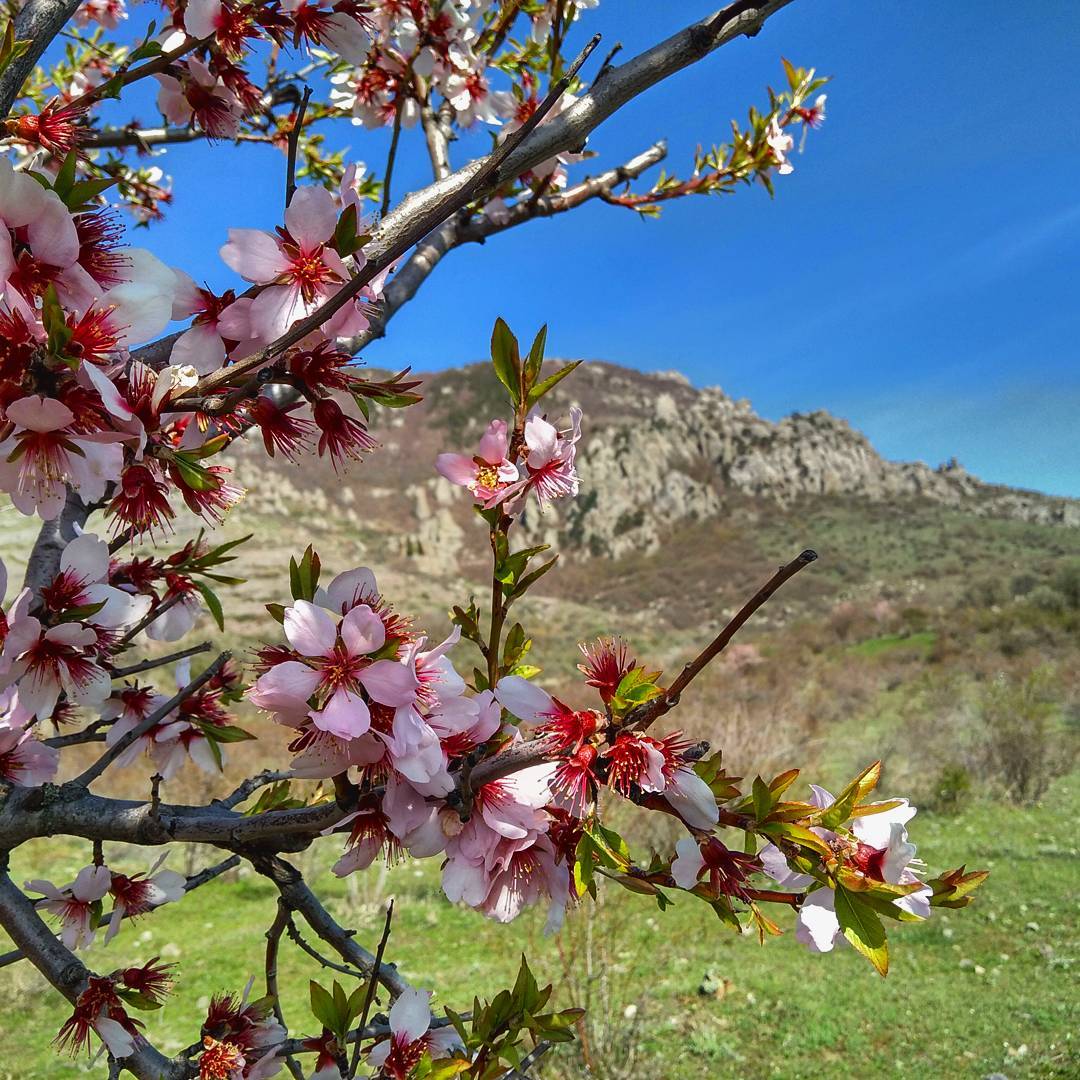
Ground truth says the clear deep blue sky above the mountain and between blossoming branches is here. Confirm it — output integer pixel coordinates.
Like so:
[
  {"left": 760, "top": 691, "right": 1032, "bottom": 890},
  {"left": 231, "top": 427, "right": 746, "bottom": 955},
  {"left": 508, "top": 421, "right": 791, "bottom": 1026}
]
[{"left": 113, "top": 0, "right": 1080, "bottom": 496}]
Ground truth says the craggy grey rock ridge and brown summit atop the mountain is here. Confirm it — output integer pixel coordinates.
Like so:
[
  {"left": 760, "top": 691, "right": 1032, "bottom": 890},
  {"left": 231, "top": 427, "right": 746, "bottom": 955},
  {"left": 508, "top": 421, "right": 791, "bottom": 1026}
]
[{"left": 234, "top": 362, "right": 1080, "bottom": 558}]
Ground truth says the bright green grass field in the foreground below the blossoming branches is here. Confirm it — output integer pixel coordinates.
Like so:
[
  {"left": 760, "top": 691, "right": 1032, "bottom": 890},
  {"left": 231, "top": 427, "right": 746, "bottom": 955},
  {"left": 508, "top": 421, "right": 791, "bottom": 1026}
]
[{"left": 0, "top": 775, "right": 1080, "bottom": 1080}]
